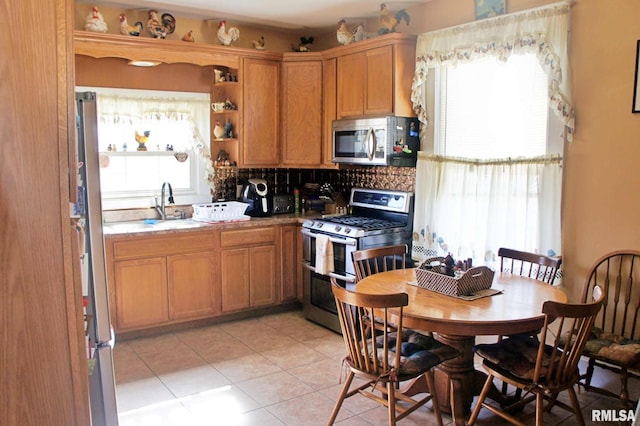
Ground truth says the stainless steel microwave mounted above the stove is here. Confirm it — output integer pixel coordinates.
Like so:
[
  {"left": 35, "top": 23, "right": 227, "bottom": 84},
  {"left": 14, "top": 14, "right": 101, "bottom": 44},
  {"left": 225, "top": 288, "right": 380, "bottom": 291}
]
[{"left": 332, "top": 116, "right": 420, "bottom": 167}]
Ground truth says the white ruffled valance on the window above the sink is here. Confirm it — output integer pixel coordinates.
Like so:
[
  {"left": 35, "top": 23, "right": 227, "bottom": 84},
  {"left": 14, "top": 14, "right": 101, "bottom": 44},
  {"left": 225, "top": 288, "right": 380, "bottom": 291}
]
[{"left": 97, "top": 93, "right": 215, "bottom": 180}]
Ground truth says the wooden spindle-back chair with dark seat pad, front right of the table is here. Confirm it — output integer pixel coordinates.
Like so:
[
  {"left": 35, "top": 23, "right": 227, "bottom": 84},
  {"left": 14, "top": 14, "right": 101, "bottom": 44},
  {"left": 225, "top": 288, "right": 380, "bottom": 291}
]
[{"left": 468, "top": 287, "right": 604, "bottom": 426}]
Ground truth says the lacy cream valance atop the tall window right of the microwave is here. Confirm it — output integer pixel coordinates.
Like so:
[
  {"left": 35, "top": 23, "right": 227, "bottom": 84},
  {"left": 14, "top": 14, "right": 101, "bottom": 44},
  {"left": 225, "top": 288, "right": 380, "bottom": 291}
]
[{"left": 411, "top": 1, "right": 575, "bottom": 141}]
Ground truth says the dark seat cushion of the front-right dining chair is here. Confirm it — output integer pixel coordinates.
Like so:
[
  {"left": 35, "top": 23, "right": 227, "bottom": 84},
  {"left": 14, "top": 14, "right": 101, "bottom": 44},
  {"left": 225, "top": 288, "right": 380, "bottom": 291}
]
[{"left": 473, "top": 336, "right": 553, "bottom": 380}]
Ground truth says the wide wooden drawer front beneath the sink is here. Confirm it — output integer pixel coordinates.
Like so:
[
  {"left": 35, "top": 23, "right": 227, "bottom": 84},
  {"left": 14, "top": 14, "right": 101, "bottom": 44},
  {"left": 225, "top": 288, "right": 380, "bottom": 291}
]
[{"left": 113, "top": 232, "right": 215, "bottom": 259}]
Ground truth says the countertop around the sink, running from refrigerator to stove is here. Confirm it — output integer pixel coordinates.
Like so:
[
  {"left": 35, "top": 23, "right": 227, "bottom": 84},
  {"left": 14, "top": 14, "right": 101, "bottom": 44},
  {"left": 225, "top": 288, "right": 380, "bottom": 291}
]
[{"left": 102, "top": 212, "right": 322, "bottom": 238}]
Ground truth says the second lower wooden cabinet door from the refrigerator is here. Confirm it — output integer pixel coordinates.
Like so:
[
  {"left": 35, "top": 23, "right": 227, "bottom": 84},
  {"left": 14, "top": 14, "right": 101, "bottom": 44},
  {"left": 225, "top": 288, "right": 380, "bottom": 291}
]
[{"left": 167, "top": 252, "right": 220, "bottom": 320}]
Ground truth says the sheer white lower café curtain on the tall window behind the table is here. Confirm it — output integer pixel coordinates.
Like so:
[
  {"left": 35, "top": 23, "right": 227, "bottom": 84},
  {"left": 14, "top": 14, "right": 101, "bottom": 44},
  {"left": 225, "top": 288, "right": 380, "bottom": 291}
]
[{"left": 412, "top": 152, "right": 562, "bottom": 265}]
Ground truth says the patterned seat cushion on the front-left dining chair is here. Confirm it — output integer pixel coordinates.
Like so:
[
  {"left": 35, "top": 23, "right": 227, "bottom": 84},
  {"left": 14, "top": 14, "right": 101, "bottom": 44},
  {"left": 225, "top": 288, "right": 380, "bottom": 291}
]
[{"left": 376, "top": 329, "right": 460, "bottom": 376}]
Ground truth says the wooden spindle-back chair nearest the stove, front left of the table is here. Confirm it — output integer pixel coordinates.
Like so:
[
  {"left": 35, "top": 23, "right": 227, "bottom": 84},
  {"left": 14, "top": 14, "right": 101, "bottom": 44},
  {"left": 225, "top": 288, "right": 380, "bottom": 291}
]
[{"left": 328, "top": 277, "right": 460, "bottom": 426}]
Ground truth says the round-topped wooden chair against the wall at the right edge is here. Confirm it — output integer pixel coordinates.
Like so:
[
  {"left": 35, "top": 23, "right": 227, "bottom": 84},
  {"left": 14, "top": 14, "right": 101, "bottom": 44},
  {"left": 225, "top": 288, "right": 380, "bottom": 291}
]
[{"left": 582, "top": 250, "right": 640, "bottom": 406}]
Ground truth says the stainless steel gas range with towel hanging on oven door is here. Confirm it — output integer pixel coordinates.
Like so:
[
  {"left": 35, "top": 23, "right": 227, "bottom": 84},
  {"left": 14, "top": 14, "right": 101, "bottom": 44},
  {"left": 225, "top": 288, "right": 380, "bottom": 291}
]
[{"left": 302, "top": 188, "right": 413, "bottom": 333}]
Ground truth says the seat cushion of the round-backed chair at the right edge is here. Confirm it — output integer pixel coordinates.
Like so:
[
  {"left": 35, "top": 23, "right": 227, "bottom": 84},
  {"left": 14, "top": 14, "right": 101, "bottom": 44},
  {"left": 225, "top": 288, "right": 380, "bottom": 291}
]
[{"left": 584, "top": 327, "right": 640, "bottom": 368}]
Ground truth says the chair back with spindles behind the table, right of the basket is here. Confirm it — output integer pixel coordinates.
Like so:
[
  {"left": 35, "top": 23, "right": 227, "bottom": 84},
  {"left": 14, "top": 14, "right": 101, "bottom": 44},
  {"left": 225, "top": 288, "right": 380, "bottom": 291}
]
[{"left": 498, "top": 247, "right": 562, "bottom": 284}]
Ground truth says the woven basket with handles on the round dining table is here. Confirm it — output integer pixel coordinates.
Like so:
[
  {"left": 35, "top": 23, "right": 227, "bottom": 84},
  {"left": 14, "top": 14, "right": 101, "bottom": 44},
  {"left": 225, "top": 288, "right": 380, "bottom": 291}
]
[{"left": 416, "top": 258, "right": 495, "bottom": 296}]
